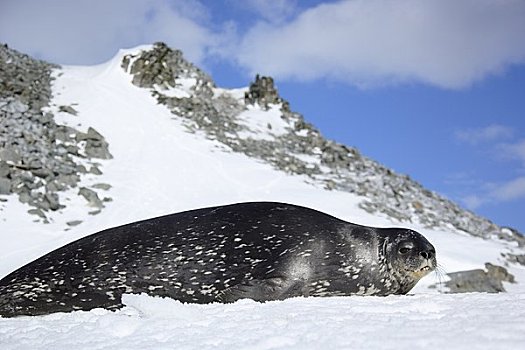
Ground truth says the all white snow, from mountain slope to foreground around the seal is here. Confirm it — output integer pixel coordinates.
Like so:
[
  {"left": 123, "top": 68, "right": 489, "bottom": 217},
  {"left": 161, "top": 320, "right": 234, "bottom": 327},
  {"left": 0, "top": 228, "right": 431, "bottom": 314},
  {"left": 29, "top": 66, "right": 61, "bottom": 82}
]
[{"left": 0, "top": 47, "right": 525, "bottom": 349}]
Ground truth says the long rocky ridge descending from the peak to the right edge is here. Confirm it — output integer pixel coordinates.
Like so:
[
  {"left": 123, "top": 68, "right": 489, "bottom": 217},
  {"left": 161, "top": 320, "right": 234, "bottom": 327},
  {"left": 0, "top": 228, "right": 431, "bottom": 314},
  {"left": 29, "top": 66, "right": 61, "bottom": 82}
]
[{"left": 122, "top": 43, "right": 525, "bottom": 247}]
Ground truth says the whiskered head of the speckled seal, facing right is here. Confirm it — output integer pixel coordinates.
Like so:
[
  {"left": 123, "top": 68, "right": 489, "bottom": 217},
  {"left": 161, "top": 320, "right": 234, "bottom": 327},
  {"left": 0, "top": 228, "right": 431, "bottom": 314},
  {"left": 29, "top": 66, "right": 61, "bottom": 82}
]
[{"left": 383, "top": 229, "right": 437, "bottom": 294}]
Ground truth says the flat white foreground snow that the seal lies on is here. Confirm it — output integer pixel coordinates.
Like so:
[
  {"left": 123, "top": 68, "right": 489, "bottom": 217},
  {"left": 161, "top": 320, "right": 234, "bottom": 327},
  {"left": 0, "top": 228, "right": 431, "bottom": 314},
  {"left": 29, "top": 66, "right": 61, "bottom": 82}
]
[{"left": 0, "top": 294, "right": 525, "bottom": 350}]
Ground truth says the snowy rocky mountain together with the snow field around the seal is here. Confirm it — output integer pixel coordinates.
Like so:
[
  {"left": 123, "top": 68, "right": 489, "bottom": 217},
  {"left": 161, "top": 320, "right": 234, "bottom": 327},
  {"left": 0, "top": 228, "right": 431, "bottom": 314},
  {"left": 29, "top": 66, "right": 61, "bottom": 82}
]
[{"left": 0, "top": 44, "right": 525, "bottom": 349}]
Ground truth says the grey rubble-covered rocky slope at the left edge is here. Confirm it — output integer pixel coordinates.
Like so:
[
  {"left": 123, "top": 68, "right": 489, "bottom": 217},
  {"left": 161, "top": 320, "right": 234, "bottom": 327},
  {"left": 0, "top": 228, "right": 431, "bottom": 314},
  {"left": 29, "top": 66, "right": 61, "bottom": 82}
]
[{"left": 0, "top": 45, "right": 111, "bottom": 221}]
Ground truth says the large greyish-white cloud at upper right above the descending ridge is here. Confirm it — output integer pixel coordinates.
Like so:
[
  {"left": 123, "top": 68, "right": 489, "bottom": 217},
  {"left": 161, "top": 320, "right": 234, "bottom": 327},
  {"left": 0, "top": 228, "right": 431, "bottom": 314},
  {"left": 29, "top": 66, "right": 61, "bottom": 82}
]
[{"left": 230, "top": 0, "right": 525, "bottom": 89}]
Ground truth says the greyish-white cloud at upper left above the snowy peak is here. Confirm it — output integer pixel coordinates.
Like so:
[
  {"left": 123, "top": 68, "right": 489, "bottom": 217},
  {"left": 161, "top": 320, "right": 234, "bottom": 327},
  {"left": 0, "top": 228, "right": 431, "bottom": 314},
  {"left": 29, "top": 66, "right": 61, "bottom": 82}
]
[{"left": 0, "top": 0, "right": 221, "bottom": 64}]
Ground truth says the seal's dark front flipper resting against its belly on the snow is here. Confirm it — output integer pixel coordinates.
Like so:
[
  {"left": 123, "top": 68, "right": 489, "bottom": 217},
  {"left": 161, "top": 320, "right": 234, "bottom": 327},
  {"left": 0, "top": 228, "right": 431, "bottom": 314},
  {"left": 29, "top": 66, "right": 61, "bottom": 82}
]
[{"left": 217, "top": 277, "right": 308, "bottom": 303}]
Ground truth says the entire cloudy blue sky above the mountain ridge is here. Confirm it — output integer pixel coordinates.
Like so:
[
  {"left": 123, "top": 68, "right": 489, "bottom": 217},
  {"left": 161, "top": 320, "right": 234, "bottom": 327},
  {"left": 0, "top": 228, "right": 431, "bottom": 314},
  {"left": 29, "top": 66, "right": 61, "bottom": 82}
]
[{"left": 0, "top": 0, "right": 525, "bottom": 232}]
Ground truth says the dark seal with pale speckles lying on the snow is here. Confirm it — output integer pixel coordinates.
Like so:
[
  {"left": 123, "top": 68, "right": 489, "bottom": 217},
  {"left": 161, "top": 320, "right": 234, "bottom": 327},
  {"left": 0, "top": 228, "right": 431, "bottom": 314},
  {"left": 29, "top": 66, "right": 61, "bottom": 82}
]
[{"left": 0, "top": 202, "right": 436, "bottom": 317}]
